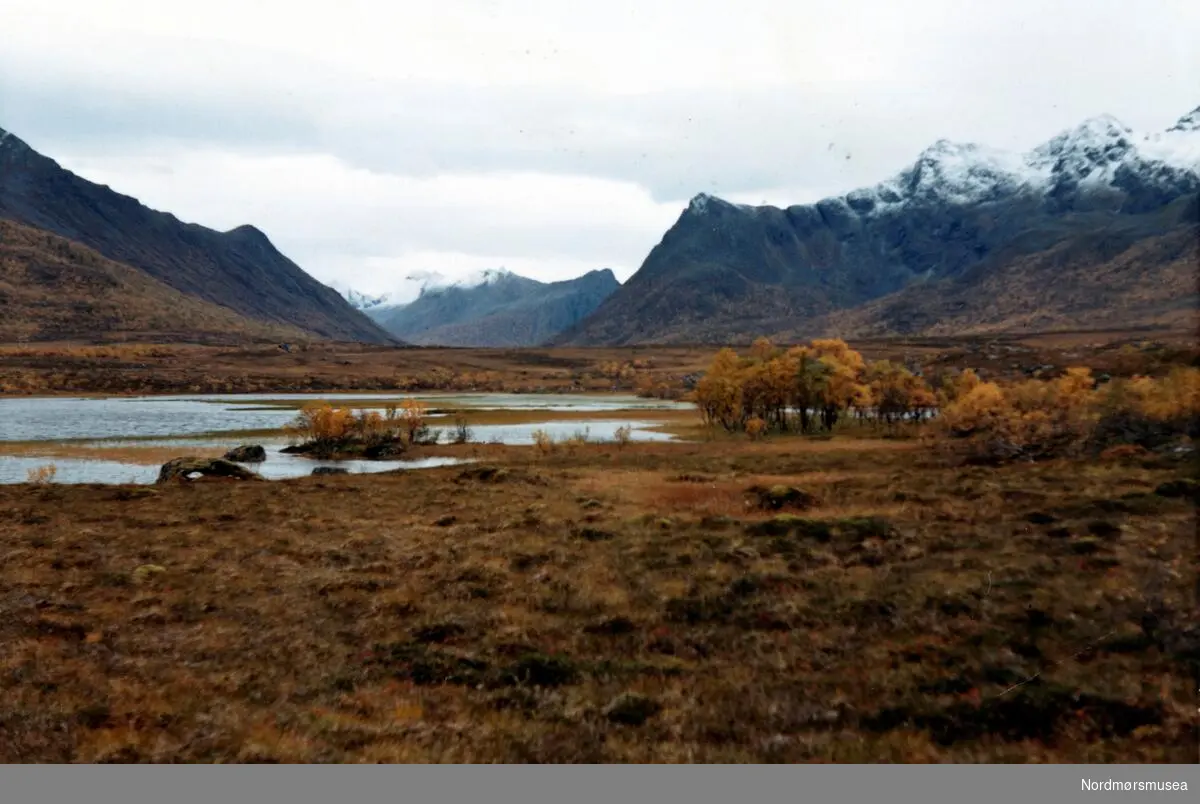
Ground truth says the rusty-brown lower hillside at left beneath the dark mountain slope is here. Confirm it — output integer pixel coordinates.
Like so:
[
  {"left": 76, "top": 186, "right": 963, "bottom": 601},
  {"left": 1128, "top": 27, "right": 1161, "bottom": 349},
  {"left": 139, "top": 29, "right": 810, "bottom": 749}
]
[{"left": 0, "top": 221, "right": 302, "bottom": 343}]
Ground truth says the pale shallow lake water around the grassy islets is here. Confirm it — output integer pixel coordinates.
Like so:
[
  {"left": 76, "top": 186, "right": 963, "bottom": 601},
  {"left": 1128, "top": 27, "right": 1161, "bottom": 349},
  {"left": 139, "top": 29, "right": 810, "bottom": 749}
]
[{"left": 0, "top": 394, "right": 686, "bottom": 484}]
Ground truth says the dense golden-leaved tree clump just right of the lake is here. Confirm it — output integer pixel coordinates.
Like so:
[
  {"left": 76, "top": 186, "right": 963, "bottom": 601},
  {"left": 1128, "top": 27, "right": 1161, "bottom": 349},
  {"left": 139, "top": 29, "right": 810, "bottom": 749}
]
[{"left": 695, "top": 338, "right": 937, "bottom": 437}]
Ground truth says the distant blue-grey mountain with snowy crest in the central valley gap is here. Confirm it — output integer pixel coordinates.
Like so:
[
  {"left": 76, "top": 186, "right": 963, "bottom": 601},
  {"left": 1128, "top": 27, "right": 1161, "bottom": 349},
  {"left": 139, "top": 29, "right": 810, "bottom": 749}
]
[{"left": 368, "top": 269, "right": 620, "bottom": 347}]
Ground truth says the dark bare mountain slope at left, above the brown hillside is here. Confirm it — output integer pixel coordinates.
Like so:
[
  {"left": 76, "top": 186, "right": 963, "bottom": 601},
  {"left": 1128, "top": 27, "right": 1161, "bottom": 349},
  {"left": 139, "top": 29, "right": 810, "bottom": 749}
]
[{"left": 0, "top": 130, "right": 391, "bottom": 343}]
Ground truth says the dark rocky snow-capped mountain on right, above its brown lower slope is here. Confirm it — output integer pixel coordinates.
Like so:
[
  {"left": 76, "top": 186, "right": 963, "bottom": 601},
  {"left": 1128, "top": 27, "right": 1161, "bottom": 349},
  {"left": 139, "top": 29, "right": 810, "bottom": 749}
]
[{"left": 553, "top": 108, "right": 1200, "bottom": 346}]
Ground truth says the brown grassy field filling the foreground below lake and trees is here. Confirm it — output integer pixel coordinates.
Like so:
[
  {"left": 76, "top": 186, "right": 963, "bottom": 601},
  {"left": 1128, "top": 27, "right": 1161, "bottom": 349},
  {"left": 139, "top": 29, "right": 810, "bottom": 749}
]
[{"left": 0, "top": 437, "right": 1200, "bottom": 762}]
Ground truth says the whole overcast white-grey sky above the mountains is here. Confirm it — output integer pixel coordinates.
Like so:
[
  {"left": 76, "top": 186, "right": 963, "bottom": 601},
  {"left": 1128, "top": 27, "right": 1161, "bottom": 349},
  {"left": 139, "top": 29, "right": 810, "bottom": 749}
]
[{"left": 0, "top": 0, "right": 1200, "bottom": 302}]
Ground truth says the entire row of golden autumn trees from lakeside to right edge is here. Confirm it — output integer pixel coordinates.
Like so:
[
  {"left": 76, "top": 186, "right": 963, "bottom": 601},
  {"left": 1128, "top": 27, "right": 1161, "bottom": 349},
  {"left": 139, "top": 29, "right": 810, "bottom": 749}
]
[{"left": 694, "top": 338, "right": 1200, "bottom": 458}]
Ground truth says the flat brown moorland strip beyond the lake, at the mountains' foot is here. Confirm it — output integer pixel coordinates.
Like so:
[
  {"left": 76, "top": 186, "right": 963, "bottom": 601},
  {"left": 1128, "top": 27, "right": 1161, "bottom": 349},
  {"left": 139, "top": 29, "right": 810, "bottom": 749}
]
[{"left": 0, "top": 330, "right": 1200, "bottom": 395}]
